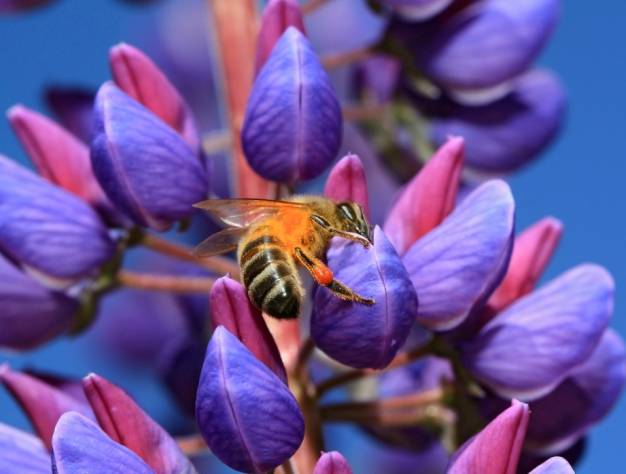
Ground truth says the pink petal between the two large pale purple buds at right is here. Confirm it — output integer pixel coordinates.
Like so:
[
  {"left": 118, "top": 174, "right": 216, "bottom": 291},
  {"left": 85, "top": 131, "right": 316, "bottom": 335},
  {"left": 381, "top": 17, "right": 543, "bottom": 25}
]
[{"left": 488, "top": 217, "right": 563, "bottom": 311}]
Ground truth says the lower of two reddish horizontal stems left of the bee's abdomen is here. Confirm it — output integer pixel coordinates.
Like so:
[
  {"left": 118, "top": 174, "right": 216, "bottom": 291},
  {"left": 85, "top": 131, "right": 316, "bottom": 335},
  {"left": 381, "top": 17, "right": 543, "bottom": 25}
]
[{"left": 117, "top": 270, "right": 215, "bottom": 293}]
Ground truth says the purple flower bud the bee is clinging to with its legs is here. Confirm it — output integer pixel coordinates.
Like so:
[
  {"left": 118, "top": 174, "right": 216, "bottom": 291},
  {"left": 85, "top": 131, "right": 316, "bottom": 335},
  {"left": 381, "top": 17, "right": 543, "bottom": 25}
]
[{"left": 311, "top": 226, "right": 418, "bottom": 369}]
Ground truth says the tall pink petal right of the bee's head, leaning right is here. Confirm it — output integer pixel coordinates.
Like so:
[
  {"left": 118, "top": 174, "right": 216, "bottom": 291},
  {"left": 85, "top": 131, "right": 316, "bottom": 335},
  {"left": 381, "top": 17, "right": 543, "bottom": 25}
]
[{"left": 384, "top": 138, "right": 465, "bottom": 254}]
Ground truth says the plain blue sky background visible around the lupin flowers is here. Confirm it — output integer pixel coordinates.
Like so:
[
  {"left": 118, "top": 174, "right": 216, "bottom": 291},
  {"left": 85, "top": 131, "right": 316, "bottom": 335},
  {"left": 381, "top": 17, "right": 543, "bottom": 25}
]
[{"left": 0, "top": 0, "right": 626, "bottom": 473}]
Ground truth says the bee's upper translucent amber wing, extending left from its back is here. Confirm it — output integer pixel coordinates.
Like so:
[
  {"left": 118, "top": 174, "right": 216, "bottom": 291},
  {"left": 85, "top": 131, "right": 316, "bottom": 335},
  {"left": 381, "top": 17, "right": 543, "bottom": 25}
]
[{"left": 194, "top": 199, "right": 307, "bottom": 228}]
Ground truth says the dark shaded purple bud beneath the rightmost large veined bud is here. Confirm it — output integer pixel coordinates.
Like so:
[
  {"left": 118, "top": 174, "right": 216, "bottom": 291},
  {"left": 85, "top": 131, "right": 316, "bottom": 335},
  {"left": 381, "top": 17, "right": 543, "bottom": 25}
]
[{"left": 526, "top": 329, "right": 626, "bottom": 454}]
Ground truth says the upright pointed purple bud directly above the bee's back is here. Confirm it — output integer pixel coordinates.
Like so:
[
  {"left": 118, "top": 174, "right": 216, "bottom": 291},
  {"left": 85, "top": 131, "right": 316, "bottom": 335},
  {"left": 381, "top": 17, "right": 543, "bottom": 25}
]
[{"left": 242, "top": 27, "right": 342, "bottom": 183}]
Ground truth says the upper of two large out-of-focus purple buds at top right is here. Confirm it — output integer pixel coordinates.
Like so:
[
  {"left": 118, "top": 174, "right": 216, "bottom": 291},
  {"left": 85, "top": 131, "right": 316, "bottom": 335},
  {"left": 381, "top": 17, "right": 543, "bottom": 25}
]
[{"left": 414, "top": 0, "right": 560, "bottom": 89}]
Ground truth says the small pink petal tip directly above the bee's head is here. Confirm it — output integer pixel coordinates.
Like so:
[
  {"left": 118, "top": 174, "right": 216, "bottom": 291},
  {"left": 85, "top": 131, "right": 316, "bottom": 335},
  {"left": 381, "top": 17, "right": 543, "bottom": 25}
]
[{"left": 324, "top": 155, "right": 369, "bottom": 218}]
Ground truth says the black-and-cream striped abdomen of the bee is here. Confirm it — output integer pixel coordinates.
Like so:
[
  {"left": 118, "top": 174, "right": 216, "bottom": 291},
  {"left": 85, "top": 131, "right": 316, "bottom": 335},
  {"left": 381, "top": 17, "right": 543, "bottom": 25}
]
[{"left": 239, "top": 235, "right": 302, "bottom": 318}]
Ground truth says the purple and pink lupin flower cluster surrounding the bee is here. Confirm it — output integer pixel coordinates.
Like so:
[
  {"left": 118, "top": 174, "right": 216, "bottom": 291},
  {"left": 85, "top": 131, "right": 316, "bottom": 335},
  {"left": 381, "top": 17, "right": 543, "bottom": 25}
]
[{"left": 0, "top": 0, "right": 626, "bottom": 474}]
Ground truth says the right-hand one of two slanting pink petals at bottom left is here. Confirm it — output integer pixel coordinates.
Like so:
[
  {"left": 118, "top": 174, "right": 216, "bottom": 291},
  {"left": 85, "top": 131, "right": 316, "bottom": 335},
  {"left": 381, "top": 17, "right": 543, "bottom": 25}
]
[{"left": 83, "top": 374, "right": 194, "bottom": 474}]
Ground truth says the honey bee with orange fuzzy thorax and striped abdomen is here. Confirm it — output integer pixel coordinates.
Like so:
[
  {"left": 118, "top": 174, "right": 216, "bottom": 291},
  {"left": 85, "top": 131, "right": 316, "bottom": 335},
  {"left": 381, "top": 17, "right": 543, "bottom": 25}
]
[{"left": 194, "top": 196, "right": 374, "bottom": 319}]
